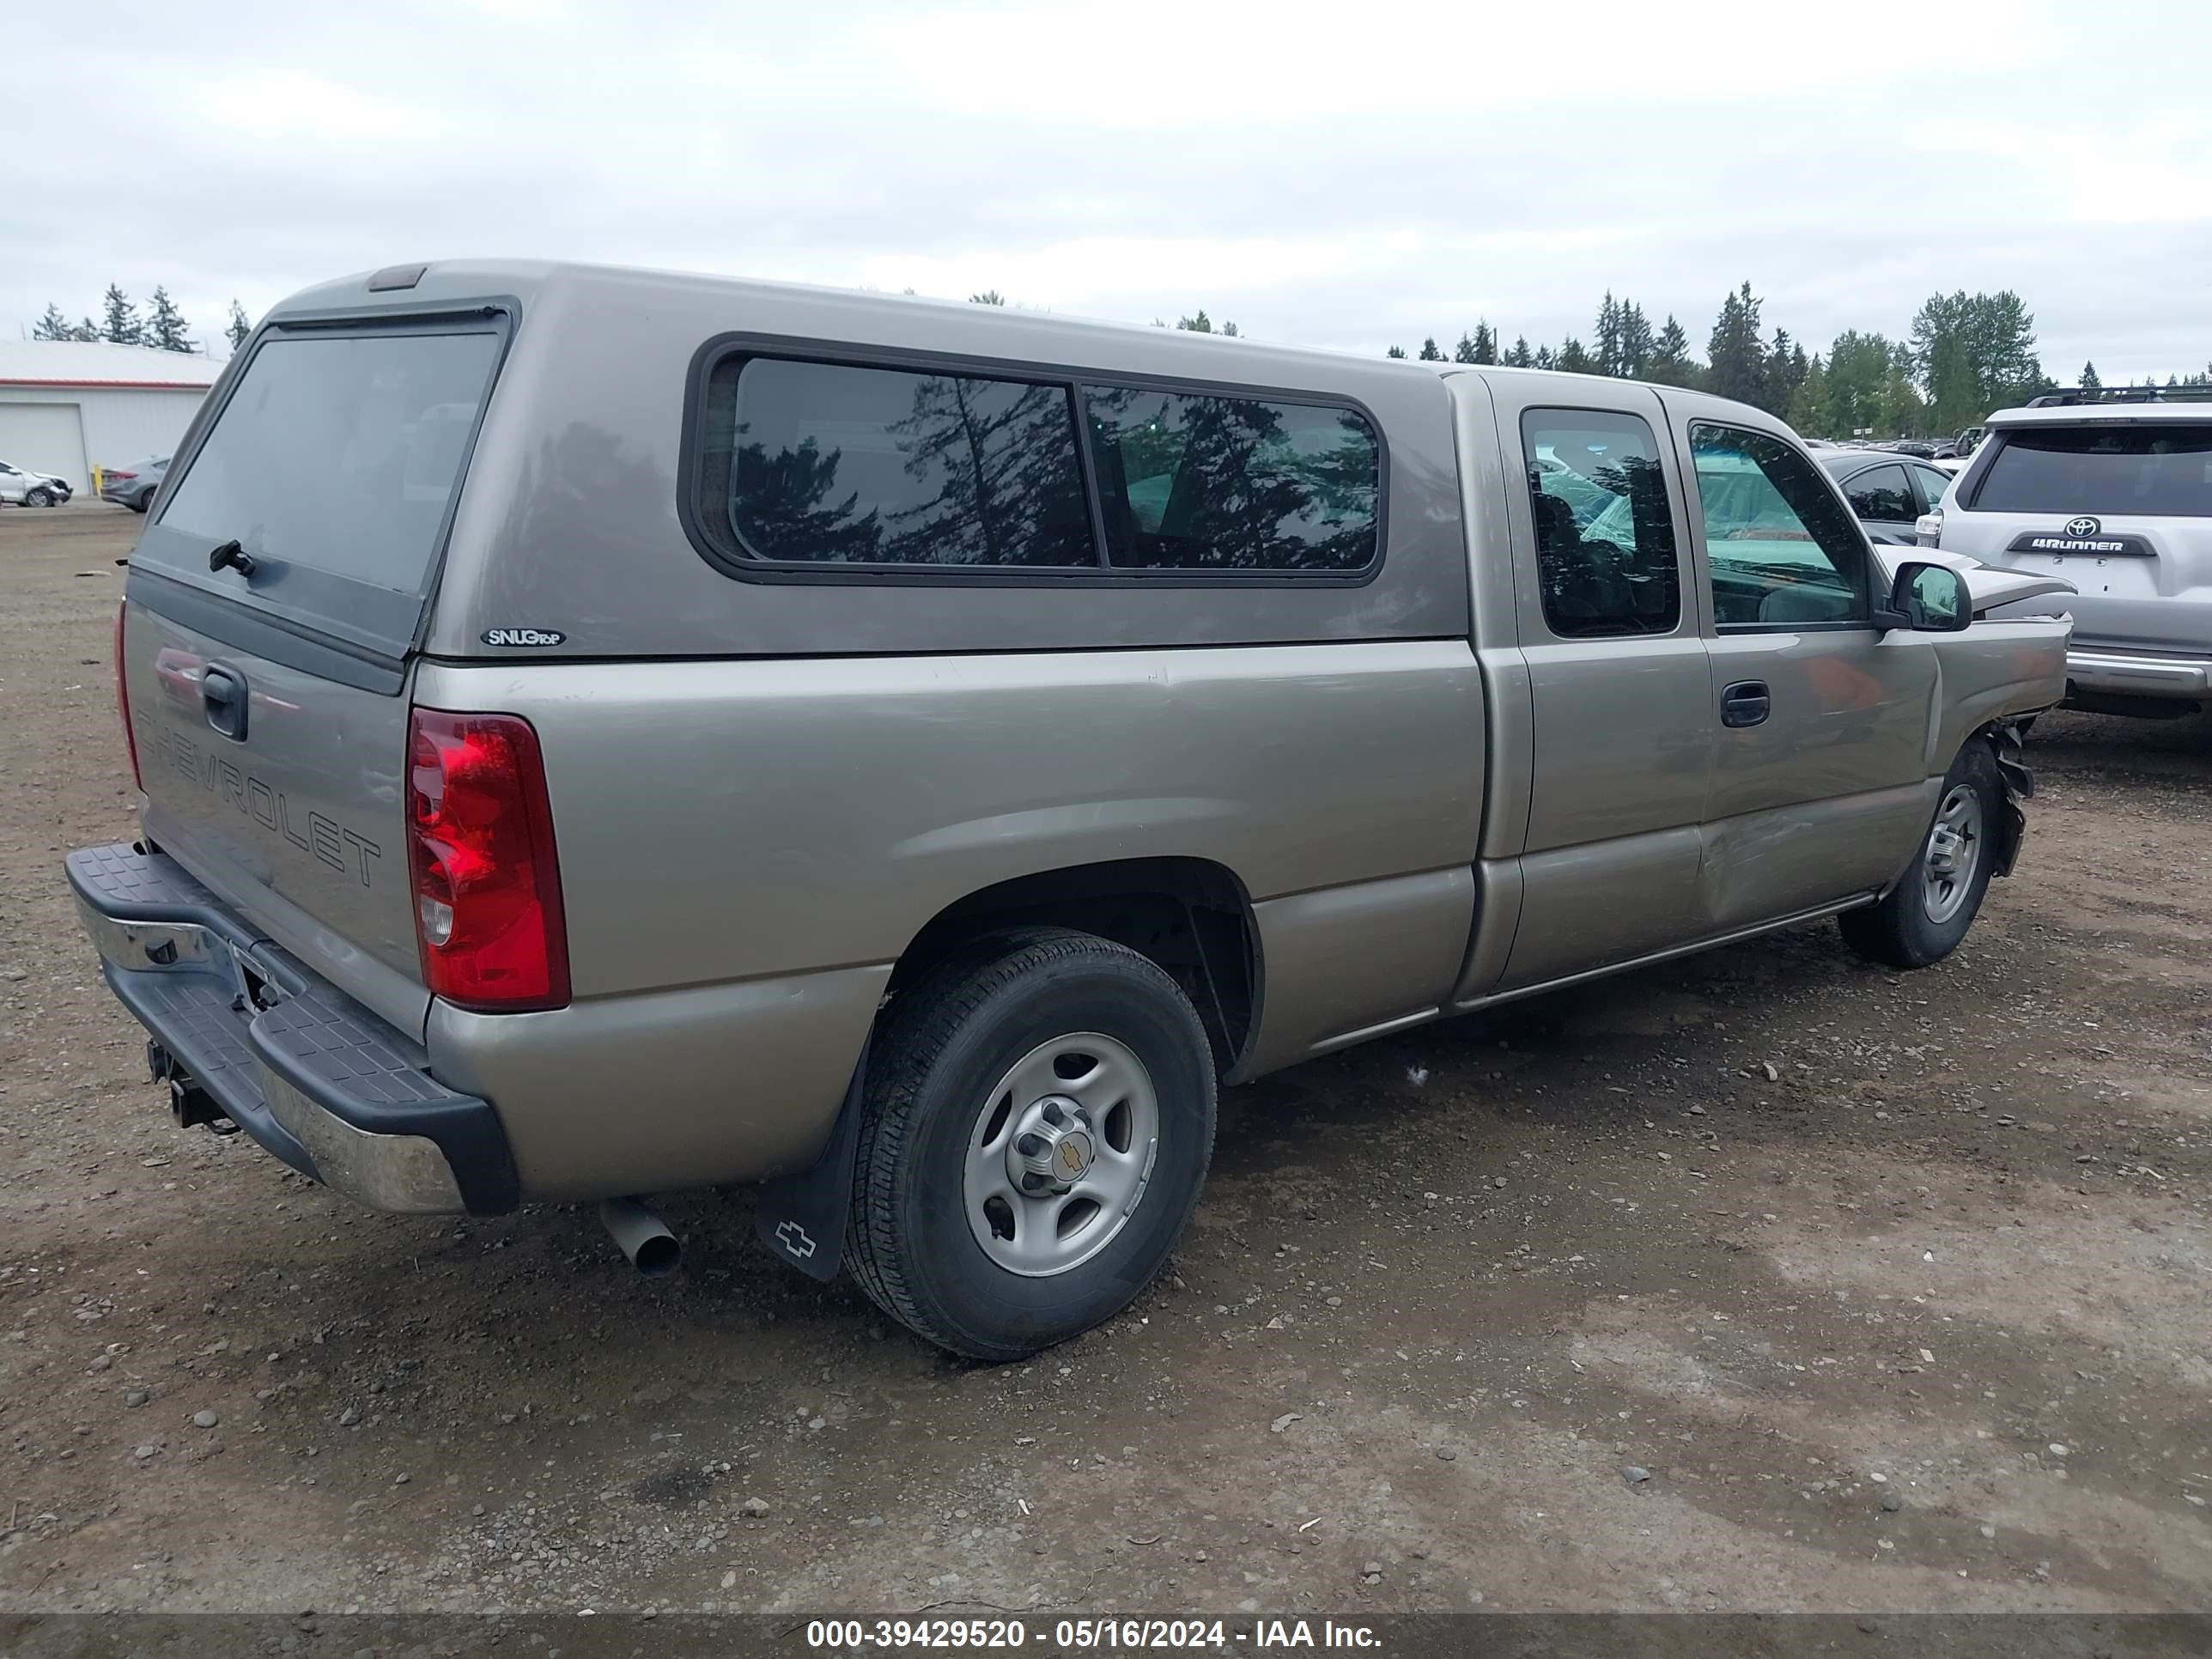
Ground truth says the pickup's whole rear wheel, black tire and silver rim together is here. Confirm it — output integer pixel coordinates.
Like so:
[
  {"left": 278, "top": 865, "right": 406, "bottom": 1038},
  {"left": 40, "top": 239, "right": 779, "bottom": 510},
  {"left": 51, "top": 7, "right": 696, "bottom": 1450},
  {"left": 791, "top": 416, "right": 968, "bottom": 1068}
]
[{"left": 848, "top": 929, "right": 1214, "bottom": 1360}]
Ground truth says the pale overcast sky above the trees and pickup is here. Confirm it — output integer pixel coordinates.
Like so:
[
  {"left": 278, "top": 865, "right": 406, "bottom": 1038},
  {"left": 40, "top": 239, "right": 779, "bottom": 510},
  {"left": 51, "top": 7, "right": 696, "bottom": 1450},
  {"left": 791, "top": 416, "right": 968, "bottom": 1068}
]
[{"left": 13, "top": 0, "right": 2212, "bottom": 380}]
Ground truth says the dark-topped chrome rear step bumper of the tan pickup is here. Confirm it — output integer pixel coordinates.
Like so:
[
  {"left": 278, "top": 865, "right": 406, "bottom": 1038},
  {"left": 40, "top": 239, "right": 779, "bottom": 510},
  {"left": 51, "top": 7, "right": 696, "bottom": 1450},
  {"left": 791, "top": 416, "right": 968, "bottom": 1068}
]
[{"left": 66, "top": 845, "right": 520, "bottom": 1214}]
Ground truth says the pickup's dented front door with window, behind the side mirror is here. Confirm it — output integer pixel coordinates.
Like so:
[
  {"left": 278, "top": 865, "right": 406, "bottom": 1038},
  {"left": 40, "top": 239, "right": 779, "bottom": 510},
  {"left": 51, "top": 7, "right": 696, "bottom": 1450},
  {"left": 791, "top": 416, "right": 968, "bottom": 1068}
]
[{"left": 1670, "top": 409, "right": 1942, "bottom": 931}]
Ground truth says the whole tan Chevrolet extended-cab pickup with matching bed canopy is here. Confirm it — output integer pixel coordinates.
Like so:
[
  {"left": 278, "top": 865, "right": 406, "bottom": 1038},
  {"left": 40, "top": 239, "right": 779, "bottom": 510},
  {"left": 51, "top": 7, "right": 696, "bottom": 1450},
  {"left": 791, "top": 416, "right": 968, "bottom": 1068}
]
[{"left": 69, "top": 264, "right": 2069, "bottom": 1358}]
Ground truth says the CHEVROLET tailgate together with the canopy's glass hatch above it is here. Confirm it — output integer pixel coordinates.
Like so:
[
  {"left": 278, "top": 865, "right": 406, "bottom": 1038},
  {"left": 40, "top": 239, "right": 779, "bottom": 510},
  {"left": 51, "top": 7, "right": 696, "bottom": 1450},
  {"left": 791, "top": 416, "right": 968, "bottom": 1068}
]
[{"left": 122, "top": 312, "right": 507, "bottom": 1033}]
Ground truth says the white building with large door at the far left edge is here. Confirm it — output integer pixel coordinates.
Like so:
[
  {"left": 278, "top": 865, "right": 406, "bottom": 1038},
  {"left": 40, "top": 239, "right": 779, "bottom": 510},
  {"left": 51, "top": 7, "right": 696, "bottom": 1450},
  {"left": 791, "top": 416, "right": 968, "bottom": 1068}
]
[{"left": 0, "top": 341, "right": 223, "bottom": 493}]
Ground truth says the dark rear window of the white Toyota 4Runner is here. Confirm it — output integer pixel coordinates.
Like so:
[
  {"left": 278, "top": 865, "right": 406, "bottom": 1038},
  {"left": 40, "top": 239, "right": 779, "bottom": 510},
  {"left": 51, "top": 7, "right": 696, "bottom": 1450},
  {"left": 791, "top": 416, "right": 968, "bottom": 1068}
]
[{"left": 1973, "top": 420, "right": 2212, "bottom": 518}]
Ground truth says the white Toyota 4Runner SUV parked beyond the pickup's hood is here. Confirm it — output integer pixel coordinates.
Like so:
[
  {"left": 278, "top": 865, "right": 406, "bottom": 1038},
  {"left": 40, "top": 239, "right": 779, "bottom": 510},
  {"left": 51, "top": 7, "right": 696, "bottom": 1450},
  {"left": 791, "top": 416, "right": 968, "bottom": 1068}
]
[{"left": 1917, "top": 387, "right": 2212, "bottom": 717}]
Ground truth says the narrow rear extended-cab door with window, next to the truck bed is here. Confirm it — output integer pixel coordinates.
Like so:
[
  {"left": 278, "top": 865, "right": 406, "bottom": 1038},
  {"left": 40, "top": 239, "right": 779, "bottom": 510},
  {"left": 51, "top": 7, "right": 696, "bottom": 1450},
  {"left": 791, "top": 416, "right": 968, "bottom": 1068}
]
[{"left": 1464, "top": 376, "right": 1717, "bottom": 991}]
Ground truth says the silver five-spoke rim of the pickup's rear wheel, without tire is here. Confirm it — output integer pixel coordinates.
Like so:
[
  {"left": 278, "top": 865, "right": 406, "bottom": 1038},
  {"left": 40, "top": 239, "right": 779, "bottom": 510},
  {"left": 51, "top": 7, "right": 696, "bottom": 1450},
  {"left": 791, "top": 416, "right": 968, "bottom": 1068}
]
[{"left": 960, "top": 1030, "right": 1159, "bottom": 1279}]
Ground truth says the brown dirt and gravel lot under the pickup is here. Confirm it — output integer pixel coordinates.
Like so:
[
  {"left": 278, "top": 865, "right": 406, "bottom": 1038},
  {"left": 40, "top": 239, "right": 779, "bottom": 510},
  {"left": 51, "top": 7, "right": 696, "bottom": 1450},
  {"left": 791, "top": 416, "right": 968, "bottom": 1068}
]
[{"left": 0, "top": 507, "right": 2212, "bottom": 1614}]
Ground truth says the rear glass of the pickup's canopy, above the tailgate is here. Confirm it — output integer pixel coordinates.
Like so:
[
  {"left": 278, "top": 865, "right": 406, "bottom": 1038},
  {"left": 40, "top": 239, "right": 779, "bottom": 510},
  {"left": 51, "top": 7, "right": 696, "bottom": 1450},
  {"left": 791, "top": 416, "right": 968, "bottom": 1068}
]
[{"left": 161, "top": 330, "right": 500, "bottom": 592}]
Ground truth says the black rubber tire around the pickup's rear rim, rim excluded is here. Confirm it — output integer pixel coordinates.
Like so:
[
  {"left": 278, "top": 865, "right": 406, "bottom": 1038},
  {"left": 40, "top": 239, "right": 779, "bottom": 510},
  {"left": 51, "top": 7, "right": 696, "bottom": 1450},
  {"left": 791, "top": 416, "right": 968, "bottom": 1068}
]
[{"left": 845, "top": 929, "right": 1214, "bottom": 1360}]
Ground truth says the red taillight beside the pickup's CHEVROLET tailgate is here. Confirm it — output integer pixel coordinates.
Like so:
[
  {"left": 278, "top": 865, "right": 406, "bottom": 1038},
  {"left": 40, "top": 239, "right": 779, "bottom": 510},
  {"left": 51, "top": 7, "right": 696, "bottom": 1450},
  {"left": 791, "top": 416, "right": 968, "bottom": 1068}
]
[{"left": 407, "top": 708, "right": 568, "bottom": 1013}]
